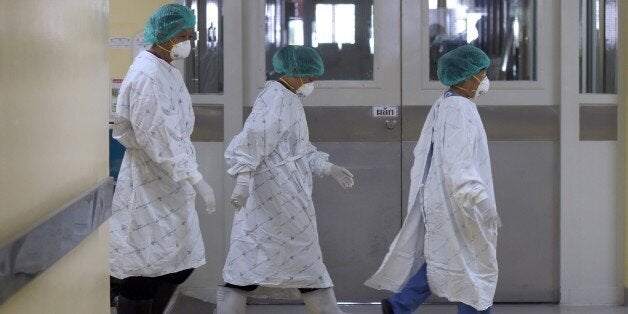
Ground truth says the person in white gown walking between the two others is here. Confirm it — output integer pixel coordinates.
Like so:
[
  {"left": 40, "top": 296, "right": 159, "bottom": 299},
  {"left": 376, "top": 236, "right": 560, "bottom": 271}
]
[{"left": 217, "top": 46, "right": 353, "bottom": 314}]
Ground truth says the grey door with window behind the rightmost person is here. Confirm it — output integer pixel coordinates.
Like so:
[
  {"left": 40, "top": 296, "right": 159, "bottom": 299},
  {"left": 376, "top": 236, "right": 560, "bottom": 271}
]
[{"left": 401, "top": 0, "right": 560, "bottom": 302}]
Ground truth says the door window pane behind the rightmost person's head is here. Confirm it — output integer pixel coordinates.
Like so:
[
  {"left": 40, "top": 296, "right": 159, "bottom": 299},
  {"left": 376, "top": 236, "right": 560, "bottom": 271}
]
[{"left": 428, "top": 0, "right": 536, "bottom": 81}]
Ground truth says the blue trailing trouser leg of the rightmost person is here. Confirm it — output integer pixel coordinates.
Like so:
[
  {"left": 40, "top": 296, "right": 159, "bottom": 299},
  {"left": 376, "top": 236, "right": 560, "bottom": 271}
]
[{"left": 388, "top": 264, "right": 432, "bottom": 314}]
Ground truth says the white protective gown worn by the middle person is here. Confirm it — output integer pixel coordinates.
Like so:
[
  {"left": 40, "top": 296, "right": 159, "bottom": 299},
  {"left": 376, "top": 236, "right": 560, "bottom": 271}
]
[{"left": 223, "top": 81, "right": 332, "bottom": 288}]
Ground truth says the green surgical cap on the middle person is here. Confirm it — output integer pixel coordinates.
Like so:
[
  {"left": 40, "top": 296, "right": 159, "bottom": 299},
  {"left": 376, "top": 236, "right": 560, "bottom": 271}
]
[{"left": 273, "top": 45, "right": 325, "bottom": 77}]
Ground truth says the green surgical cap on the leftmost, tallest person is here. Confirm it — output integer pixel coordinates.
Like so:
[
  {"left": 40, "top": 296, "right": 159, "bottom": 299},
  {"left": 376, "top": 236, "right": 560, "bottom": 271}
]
[{"left": 144, "top": 3, "right": 196, "bottom": 44}]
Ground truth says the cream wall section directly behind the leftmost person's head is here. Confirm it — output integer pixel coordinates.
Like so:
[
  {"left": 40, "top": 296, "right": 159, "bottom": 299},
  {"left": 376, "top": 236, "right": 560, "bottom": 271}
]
[{"left": 109, "top": 0, "right": 175, "bottom": 78}]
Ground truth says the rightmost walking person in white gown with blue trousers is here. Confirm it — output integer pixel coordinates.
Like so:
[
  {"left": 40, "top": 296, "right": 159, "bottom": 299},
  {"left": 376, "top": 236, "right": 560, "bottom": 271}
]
[{"left": 365, "top": 45, "right": 501, "bottom": 314}]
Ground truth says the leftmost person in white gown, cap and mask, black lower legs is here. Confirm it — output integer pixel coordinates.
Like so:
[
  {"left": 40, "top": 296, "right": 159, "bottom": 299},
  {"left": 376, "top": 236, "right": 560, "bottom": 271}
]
[{"left": 109, "top": 4, "right": 215, "bottom": 314}]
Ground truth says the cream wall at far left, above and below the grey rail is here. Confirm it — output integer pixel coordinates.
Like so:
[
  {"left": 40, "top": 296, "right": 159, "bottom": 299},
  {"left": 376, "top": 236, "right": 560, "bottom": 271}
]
[{"left": 0, "top": 0, "right": 109, "bottom": 313}]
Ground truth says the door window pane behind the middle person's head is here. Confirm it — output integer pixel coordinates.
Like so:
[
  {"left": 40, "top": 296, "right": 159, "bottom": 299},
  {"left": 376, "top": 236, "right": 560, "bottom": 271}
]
[{"left": 265, "top": 0, "right": 374, "bottom": 80}]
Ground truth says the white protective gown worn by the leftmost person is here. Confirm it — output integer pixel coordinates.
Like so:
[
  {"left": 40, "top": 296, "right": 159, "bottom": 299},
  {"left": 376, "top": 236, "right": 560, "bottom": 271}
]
[{"left": 110, "top": 51, "right": 205, "bottom": 278}]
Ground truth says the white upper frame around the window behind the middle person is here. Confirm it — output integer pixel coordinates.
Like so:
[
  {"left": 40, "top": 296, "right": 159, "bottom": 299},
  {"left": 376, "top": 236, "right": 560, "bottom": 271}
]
[{"left": 244, "top": 0, "right": 401, "bottom": 107}]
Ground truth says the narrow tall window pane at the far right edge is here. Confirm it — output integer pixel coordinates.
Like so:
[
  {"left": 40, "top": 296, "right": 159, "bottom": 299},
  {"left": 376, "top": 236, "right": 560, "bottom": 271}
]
[{"left": 580, "top": 0, "right": 617, "bottom": 94}]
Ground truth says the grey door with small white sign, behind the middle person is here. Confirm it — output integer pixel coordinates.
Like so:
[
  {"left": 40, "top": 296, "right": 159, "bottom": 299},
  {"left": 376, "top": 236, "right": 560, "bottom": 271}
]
[{"left": 244, "top": 0, "right": 403, "bottom": 302}]
